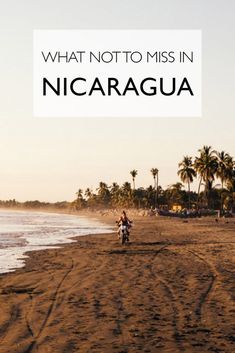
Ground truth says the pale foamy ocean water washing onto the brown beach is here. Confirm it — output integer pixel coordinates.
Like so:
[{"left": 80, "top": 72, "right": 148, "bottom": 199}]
[{"left": 0, "top": 210, "right": 112, "bottom": 273}]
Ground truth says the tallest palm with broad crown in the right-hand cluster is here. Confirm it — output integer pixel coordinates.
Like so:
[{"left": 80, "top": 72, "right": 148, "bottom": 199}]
[{"left": 194, "top": 146, "right": 218, "bottom": 206}]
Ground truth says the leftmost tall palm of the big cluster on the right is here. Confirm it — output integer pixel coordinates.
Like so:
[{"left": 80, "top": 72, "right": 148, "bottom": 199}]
[{"left": 178, "top": 156, "right": 197, "bottom": 209}]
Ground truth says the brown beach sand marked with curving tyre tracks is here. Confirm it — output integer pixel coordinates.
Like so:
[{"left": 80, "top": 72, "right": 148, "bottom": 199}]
[{"left": 0, "top": 216, "right": 235, "bottom": 353}]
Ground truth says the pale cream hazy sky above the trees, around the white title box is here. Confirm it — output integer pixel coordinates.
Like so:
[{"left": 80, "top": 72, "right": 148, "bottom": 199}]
[{"left": 0, "top": 0, "right": 235, "bottom": 202}]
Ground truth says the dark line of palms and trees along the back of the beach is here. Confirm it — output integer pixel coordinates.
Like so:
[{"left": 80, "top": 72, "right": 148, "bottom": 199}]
[{"left": 71, "top": 146, "right": 235, "bottom": 211}]
